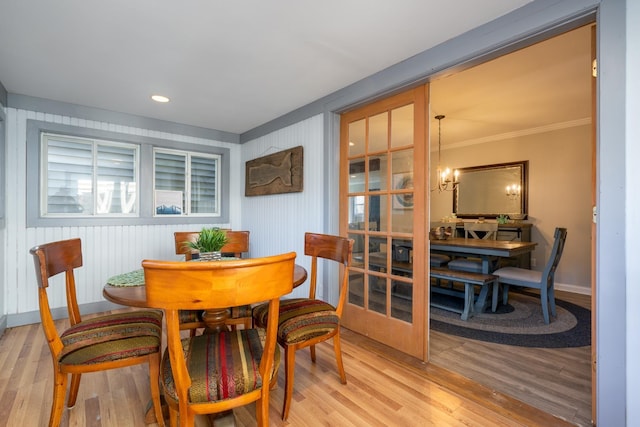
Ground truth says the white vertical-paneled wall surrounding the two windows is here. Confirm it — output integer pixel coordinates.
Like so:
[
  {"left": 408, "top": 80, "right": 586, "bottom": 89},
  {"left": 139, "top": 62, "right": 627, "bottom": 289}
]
[{"left": 0, "top": 108, "right": 243, "bottom": 326}]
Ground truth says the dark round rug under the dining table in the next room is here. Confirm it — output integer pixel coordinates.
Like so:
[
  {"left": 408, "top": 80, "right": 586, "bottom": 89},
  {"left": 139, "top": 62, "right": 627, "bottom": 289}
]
[{"left": 431, "top": 291, "right": 591, "bottom": 348}]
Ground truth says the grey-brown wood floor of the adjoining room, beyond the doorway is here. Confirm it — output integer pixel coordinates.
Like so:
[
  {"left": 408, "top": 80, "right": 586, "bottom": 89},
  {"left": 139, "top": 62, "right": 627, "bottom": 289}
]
[{"left": 430, "top": 291, "right": 592, "bottom": 426}]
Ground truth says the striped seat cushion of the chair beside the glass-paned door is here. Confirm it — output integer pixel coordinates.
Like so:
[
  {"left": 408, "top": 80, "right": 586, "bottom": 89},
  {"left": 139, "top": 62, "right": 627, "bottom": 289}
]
[{"left": 253, "top": 298, "right": 340, "bottom": 344}]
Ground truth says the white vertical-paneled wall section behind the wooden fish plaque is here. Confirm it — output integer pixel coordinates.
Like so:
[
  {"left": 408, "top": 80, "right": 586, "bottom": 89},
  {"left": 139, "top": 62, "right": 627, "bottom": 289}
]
[{"left": 242, "top": 115, "right": 324, "bottom": 297}]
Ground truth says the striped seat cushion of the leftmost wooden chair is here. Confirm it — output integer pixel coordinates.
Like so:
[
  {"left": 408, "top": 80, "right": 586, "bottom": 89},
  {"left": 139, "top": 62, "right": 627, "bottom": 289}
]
[{"left": 59, "top": 310, "right": 162, "bottom": 365}]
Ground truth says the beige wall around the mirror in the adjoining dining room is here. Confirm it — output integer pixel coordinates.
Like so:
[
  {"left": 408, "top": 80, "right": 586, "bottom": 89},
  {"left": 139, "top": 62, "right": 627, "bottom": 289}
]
[{"left": 431, "top": 124, "right": 591, "bottom": 293}]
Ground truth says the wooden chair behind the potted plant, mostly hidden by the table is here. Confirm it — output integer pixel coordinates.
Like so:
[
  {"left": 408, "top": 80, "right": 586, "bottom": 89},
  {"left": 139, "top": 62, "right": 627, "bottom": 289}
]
[{"left": 173, "top": 230, "right": 252, "bottom": 334}]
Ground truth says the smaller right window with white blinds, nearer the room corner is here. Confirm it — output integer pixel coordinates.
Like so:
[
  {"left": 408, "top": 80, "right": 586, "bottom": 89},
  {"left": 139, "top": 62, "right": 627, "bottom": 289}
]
[{"left": 153, "top": 148, "right": 221, "bottom": 216}]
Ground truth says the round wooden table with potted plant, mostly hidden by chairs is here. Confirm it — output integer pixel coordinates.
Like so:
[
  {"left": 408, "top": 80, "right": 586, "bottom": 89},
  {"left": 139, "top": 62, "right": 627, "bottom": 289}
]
[{"left": 102, "top": 264, "right": 307, "bottom": 331}]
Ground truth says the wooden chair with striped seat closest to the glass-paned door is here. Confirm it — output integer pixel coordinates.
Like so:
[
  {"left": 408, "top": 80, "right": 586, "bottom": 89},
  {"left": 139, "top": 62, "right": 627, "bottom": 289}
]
[{"left": 253, "top": 233, "right": 353, "bottom": 420}]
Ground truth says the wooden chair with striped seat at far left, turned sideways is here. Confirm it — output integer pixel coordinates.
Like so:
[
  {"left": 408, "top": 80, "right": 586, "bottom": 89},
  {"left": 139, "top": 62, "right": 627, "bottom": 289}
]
[{"left": 30, "top": 239, "right": 164, "bottom": 427}]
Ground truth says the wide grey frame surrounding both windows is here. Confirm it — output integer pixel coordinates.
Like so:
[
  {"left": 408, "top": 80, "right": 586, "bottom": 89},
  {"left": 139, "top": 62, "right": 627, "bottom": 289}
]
[{"left": 26, "top": 119, "right": 231, "bottom": 227}]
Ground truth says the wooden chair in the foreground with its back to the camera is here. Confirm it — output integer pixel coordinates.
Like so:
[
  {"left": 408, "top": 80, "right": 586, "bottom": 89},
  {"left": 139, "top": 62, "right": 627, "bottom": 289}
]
[{"left": 142, "top": 252, "right": 296, "bottom": 427}]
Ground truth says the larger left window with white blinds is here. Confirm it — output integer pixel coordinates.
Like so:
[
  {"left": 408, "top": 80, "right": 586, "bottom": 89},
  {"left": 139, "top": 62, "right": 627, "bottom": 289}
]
[{"left": 40, "top": 133, "right": 140, "bottom": 217}]
